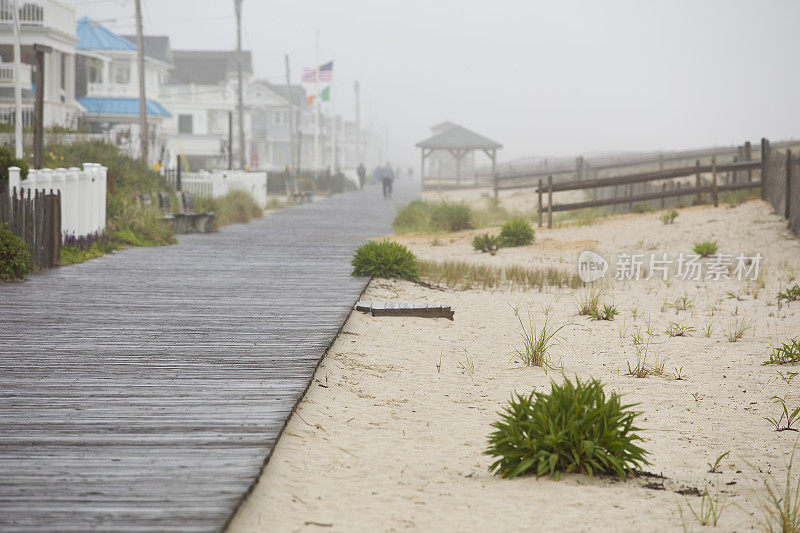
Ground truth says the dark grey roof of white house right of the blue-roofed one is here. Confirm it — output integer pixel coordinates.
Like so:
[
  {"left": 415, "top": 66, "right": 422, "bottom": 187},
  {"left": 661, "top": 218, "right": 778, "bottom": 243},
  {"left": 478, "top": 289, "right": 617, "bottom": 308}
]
[{"left": 169, "top": 50, "right": 253, "bottom": 85}]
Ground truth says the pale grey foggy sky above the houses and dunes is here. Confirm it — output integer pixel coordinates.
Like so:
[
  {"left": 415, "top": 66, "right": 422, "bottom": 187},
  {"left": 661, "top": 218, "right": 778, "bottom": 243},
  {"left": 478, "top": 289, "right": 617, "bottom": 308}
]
[{"left": 73, "top": 0, "right": 800, "bottom": 163}]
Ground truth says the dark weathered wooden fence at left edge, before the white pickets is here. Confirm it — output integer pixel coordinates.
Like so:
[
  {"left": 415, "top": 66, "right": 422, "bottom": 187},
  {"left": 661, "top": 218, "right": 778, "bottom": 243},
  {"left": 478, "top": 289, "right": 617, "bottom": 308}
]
[{"left": 0, "top": 187, "right": 61, "bottom": 268}]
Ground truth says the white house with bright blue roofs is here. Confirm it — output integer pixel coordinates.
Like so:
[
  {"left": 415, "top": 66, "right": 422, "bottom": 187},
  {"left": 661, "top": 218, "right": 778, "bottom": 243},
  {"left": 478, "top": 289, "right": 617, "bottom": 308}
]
[{"left": 75, "top": 17, "right": 172, "bottom": 162}]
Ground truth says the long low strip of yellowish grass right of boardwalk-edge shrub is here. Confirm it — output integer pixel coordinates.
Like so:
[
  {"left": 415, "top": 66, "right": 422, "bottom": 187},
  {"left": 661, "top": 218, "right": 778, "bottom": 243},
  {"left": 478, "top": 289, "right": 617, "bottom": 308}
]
[{"left": 418, "top": 260, "right": 583, "bottom": 290}]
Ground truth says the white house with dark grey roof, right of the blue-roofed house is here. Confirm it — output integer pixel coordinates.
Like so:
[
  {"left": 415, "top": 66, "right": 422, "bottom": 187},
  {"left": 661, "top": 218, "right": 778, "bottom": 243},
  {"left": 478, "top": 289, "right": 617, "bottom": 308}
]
[{"left": 160, "top": 50, "right": 253, "bottom": 170}]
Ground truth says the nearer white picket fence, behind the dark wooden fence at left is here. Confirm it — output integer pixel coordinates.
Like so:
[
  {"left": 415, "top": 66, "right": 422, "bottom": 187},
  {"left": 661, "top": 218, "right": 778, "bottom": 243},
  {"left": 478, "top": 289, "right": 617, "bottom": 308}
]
[{"left": 8, "top": 163, "right": 108, "bottom": 236}]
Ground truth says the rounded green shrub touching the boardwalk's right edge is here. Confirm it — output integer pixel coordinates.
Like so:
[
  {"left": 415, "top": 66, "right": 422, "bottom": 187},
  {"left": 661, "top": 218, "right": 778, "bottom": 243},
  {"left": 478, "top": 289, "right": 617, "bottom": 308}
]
[{"left": 350, "top": 239, "right": 419, "bottom": 281}]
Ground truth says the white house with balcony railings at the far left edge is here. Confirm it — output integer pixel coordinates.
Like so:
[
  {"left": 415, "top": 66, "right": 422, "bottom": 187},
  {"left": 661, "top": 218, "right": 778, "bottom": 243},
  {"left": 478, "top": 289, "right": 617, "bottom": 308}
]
[{"left": 0, "top": 0, "right": 80, "bottom": 128}]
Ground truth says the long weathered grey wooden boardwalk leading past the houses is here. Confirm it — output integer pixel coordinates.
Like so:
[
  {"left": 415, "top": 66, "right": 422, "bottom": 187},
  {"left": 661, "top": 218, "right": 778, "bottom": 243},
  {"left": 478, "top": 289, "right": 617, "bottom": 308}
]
[{"left": 0, "top": 182, "right": 418, "bottom": 531}]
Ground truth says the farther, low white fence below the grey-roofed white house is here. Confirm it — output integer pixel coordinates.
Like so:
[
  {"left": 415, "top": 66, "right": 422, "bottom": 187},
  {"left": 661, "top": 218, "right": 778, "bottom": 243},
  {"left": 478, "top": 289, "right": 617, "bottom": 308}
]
[{"left": 181, "top": 170, "right": 267, "bottom": 208}]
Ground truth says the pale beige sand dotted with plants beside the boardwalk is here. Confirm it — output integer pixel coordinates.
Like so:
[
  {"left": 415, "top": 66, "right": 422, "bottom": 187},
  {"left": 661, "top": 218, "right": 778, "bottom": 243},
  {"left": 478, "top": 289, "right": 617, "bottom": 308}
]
[{"left": 230, "top": 197, "right": 800, "bottom": 532}]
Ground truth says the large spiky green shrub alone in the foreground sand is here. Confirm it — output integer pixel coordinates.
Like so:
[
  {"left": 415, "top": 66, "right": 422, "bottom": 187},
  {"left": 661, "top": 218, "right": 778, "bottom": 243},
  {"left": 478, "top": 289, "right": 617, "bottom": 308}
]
[{"left": 484, "top": 378, "right": 649, "bottom": 479}]
